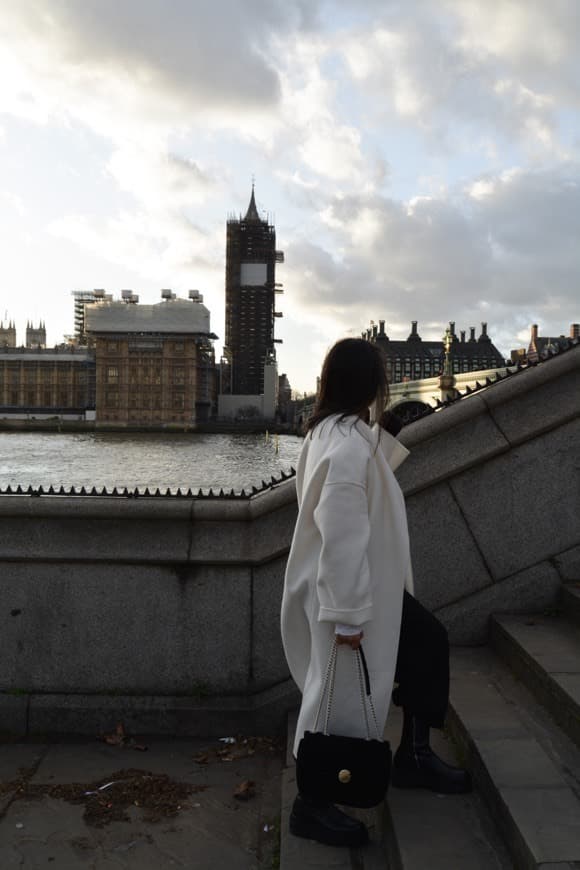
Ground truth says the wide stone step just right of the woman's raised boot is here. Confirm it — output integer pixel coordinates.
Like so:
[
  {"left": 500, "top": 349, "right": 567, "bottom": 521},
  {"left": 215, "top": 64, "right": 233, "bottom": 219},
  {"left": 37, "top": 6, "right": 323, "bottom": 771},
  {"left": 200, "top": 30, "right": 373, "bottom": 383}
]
[{"left": 449, "top": 648, "right": 580, "bottom": 870}]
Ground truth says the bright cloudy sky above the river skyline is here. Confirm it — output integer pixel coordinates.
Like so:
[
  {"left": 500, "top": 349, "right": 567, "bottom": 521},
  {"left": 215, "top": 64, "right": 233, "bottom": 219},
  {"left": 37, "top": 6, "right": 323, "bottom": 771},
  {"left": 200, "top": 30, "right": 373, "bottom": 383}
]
[{"left": 0, "top": 0, "right": 580, "bottom": 391}]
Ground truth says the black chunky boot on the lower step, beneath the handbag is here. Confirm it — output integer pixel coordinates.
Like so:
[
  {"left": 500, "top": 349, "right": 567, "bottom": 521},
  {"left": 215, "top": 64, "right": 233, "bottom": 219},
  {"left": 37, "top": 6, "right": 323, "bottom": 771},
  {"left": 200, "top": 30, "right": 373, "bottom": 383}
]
[{"left": 290, "top": 794, "right": 369, "bottom": 847}]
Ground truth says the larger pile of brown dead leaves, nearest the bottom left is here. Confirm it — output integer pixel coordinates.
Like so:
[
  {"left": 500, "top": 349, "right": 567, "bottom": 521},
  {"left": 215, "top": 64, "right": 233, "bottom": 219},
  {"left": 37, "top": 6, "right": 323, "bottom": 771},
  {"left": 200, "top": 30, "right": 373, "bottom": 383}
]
[{"left": 2, "top": 768, "right": 206, "bottom": 828}]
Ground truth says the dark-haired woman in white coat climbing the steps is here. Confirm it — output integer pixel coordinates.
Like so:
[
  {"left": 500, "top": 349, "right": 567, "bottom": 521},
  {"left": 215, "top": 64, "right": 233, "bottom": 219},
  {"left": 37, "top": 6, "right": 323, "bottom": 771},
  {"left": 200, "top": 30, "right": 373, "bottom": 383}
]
[{"left": 282, "top": 338, "right": 470, "bottom": 846}]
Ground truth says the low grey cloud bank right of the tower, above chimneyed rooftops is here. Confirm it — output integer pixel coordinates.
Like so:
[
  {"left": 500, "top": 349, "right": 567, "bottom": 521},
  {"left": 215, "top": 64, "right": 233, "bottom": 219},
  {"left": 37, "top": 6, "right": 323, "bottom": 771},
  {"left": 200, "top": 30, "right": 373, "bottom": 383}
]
[{"left": 289, "top": 165, "right": 580, "bottom": 349}]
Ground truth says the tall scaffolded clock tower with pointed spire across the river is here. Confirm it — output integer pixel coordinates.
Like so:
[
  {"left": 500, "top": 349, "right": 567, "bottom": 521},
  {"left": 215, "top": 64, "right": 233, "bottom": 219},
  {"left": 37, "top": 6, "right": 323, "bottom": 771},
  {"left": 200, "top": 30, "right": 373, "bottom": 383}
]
[{"left": 219, "top": 185, "right": 284, "bottom": 418}]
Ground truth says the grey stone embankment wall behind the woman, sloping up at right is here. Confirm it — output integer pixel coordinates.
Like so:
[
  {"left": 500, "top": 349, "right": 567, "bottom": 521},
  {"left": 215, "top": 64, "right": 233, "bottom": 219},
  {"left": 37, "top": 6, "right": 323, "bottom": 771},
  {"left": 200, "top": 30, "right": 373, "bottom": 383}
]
[{"left": 0, "top": 347, "right": 580, "bottom": 735}]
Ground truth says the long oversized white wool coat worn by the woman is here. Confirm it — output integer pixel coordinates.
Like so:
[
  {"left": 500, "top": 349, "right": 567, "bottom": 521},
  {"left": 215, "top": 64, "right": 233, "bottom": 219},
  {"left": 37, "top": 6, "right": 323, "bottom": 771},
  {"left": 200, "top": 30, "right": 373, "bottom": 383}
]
[{"left": 281, "top": 415, "right": 413, "bottom": 754}]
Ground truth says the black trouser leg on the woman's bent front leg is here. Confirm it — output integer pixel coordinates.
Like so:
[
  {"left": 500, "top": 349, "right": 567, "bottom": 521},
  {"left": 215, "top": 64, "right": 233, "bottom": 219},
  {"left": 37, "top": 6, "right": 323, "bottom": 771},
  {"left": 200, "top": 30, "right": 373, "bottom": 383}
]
[{"left": 393, "top": 591, "right": 449, "bottom": 728}]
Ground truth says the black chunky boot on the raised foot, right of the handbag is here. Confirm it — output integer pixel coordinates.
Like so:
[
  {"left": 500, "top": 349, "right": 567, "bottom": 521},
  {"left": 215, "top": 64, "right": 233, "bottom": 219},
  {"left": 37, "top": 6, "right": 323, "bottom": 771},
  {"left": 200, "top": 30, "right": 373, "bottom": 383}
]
[{"left": 391, "top": 711, "right": 472, "bottom": 794}]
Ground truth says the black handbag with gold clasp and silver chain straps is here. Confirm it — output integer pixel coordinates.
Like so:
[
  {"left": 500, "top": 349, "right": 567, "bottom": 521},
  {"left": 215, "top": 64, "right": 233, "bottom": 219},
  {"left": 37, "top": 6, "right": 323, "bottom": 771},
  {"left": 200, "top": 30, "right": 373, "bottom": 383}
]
[{"left": 296, "top": 640, "right": 392, "bottom": 808}]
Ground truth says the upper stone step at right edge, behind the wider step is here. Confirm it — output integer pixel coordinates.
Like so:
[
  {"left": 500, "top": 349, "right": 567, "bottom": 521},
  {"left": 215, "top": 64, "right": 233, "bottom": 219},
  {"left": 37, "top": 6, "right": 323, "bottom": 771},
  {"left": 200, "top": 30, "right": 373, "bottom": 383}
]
[{"left": 491, "top": 615, "right": 580, "bottom": 746}]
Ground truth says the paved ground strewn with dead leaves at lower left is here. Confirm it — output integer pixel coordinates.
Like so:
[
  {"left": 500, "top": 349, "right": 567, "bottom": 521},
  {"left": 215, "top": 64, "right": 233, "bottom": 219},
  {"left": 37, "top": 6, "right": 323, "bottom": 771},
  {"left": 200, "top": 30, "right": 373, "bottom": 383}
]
[{"left": 0, "top": 735, "right": 283, "bottom": 870}]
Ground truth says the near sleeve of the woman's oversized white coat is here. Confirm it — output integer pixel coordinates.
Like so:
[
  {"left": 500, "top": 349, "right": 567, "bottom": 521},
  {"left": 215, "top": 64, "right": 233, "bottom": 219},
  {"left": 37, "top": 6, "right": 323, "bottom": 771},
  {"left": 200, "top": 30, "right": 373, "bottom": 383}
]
[{"left": 314, "top": 446, "right": 373, "bottom": 626}]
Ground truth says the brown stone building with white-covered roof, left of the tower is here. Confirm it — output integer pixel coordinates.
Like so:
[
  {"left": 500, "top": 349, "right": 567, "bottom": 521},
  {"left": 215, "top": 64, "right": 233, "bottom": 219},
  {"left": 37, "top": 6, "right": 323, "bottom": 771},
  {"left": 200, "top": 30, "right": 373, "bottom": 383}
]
[{"left": 83, "top": 290, "right": 217, "bottom": 428}]
